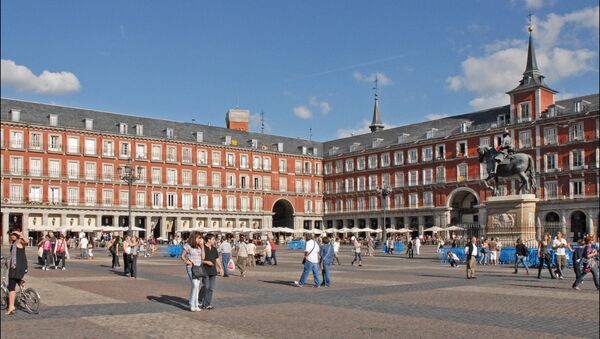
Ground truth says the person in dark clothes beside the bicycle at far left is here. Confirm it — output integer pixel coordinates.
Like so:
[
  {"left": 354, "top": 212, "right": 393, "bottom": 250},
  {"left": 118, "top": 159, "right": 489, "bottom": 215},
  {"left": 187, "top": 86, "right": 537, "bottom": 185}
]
[{"left": 6, "top": 230, "right": 29, "bottom": 315}]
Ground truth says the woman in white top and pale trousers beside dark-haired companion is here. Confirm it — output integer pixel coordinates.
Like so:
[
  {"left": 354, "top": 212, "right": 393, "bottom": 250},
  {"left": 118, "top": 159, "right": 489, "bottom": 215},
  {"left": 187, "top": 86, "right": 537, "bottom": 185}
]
[{"left": 181, "top": 231, "right": 204, "bottom": 312}]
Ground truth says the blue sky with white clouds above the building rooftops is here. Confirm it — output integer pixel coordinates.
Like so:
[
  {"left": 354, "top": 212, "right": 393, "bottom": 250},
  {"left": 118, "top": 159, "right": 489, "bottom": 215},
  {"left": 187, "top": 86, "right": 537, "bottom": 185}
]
[{"left": 1, "top": 0, "right": 599, "bottom": 140}]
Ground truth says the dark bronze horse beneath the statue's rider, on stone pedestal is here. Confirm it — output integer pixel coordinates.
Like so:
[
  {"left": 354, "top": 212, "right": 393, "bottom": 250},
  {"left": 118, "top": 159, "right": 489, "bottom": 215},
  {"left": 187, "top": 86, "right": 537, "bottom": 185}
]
[{"left": 477, "top": 146, "right": 536, "bottom": 196}]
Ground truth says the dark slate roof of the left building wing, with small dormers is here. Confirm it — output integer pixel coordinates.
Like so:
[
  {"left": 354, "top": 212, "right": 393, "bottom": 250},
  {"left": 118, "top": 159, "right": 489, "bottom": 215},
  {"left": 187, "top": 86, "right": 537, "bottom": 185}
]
[{"left": 0, "top": 98, "right": 323, "bottom": 156}]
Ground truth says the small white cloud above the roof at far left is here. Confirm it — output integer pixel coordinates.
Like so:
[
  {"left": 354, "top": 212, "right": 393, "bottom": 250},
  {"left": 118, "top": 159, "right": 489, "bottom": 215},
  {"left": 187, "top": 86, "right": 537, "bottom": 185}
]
[{"left": 0, "top": 59, "right": 81, "bottom": 94}]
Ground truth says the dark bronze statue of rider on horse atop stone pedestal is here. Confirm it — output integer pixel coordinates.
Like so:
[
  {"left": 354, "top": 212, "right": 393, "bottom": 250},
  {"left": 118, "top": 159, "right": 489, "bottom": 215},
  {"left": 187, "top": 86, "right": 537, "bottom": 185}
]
[{"left": 477, "top": 130, "right": 536, "bottom": 196}]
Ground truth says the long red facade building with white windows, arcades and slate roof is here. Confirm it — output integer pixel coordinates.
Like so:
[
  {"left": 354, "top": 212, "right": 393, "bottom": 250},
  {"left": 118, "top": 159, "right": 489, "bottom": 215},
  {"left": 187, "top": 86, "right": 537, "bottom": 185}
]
[{"left": 0, "top": 31, "right": 600, "bottom": 244}]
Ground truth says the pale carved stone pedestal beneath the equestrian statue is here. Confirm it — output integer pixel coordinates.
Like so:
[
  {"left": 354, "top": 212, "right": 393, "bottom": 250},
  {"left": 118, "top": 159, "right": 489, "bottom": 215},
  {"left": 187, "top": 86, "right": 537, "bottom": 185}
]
[{"left": 485, "top": 194, "right": 537, "bottom": 247}]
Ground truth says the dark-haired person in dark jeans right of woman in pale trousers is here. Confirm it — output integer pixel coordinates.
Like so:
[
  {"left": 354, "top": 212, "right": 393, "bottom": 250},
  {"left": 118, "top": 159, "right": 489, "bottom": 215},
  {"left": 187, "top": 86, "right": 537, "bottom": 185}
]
[{"left": 199, "top": 233, "right": 223, "bottom": 310}]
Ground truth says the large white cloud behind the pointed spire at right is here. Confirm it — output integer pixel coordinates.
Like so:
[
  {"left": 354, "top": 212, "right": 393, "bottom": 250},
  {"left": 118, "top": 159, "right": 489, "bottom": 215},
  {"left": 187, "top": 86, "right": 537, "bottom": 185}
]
[{"left": 446, "top": 6, "right": 600, "bottom": 109}]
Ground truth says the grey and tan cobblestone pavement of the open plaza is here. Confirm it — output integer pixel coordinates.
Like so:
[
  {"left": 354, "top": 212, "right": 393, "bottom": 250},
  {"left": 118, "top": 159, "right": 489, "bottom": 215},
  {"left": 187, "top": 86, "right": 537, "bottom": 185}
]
[{"left": 1, "top": 246, "right": 599, "bottom": 338}]
